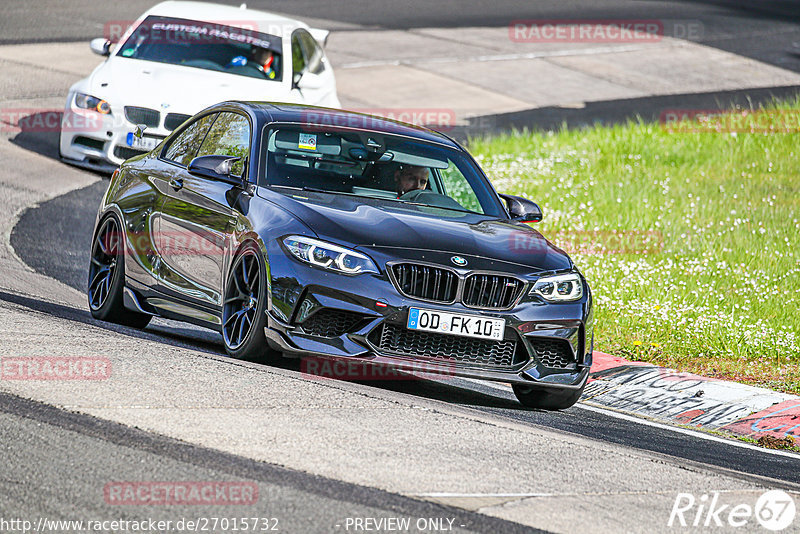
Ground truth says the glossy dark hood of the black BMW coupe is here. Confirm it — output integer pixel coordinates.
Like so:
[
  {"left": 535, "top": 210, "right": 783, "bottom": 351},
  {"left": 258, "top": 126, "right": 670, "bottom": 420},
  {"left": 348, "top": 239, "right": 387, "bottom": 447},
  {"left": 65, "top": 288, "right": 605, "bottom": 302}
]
[{"left": 264, "top": 191, "right": 572, "bottom": 272}]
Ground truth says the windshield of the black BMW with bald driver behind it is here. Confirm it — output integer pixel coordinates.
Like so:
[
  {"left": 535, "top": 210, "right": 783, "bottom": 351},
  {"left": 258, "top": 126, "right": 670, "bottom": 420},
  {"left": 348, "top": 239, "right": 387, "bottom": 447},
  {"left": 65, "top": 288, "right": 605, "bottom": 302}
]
[{"left": 259, "top": 126, "right": 500, "bottom": 217}]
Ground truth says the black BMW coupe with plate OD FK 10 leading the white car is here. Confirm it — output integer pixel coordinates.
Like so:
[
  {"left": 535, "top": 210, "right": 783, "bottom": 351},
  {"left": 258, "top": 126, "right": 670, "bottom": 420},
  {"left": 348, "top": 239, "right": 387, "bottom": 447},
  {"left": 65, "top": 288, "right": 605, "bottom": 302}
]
[{"left": 88, "top": 102, "right": 593, "bottom": 409}]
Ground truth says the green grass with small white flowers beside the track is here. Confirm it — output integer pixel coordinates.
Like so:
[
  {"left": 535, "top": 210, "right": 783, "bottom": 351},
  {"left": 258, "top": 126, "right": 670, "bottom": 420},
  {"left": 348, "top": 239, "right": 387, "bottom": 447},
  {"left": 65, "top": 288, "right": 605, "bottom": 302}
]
[{"left": 469, "top": 98, "right": 800, "bottom": 393}]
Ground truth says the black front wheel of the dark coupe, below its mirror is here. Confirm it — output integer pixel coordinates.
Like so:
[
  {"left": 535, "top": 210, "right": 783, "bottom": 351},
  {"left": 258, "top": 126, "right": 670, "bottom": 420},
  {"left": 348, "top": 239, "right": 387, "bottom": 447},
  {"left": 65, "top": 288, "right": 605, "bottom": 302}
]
[{"left": 222, "top": 243, "right": 276, "bottom": 361}]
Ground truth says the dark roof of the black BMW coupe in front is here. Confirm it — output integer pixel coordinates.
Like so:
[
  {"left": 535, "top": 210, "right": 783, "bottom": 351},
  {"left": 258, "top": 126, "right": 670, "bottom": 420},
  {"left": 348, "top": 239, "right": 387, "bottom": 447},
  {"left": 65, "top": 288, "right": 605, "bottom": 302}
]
[{"left": 234, "top": 101, "right": 463, "bottom": 150}]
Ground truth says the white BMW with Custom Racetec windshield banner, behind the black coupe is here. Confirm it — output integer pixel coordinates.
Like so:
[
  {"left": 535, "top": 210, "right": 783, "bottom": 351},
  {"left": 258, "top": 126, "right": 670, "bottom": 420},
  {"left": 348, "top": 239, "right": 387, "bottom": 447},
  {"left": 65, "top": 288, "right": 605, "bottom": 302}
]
[{"left": 59, "top": 1, "right": 340, "bottom": 171}]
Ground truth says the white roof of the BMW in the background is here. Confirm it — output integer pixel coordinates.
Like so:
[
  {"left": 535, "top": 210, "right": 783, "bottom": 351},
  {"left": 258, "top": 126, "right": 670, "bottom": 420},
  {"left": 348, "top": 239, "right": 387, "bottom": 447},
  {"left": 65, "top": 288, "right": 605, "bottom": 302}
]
[{"left": 143, "top": 0, "right": 308, "bottom": 37}]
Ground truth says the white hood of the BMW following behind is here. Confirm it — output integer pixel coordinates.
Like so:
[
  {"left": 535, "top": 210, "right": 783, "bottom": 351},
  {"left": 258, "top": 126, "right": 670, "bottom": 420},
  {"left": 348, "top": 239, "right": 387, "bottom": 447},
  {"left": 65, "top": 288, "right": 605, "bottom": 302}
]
[{"left": 89, "top": 56, "right": 291, "bottom": 115}]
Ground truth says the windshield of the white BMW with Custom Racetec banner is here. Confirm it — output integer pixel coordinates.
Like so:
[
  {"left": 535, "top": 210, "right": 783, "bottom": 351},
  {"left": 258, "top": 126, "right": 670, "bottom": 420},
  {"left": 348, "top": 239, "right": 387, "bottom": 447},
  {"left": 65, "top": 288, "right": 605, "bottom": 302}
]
[{"left": 117, "top": 16, "right": 282, "bottom": 81}]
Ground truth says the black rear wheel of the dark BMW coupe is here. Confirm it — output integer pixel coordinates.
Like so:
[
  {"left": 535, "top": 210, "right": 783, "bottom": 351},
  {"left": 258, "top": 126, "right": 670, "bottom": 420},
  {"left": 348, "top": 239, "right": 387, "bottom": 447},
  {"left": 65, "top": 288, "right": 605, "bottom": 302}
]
[{"left": 86, "top": 215, "right": 151, "bottom": 328}]
